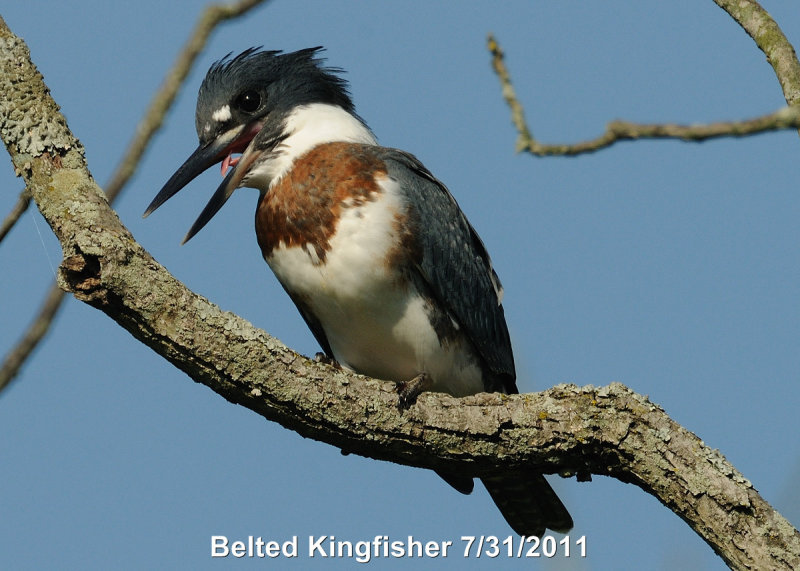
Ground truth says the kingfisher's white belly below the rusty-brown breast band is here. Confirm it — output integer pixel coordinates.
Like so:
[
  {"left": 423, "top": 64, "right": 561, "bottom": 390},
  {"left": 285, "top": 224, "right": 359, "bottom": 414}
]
[{"left": 267, "top": 188, "right": 484, "bottom": 396}]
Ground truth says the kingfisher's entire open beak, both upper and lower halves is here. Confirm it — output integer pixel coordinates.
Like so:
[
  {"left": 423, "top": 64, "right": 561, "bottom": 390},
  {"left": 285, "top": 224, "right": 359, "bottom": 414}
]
[{"left": 142, "top": 123, "right": 262, "bottom": 243}]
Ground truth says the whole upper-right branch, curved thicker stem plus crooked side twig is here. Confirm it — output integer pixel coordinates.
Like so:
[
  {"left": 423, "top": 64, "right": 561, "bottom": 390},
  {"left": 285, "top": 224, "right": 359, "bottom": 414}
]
[{"left": 488, "top": 0, "right": 800, "bottom": 157}]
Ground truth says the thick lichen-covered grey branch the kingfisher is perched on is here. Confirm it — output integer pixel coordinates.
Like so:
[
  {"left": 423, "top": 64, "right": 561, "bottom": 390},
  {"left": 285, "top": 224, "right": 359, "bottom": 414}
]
[{"left": 0, "top": 15, "right": 800, "bottom": 569}]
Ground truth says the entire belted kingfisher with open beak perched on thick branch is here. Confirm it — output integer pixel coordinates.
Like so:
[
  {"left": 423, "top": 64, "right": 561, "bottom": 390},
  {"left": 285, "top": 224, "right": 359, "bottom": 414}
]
[{"left": 144, "top": 47, "right": 572, "bottom": 536}]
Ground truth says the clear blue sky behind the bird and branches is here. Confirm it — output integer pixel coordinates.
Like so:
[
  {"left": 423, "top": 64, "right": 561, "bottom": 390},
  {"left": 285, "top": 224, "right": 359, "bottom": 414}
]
[{"left": 0, "top": 0, "right": 800, "bottom": 570}]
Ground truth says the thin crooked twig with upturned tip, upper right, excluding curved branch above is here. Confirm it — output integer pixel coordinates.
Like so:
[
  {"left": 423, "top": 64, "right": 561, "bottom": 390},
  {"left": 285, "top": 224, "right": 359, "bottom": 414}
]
[{"left": 488, "top": 35, "right": 800, "bottom": 157}]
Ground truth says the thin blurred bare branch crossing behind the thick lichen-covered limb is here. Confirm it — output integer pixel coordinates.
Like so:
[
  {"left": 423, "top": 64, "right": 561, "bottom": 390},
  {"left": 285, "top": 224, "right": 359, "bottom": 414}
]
[{"left": 0, "top": 0, "right": 264, "bottom": 392}]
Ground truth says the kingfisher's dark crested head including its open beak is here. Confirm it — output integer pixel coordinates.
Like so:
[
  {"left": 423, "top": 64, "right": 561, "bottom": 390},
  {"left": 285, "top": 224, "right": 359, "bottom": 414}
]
[{"left": 144, "top": 47, "right": 368, "bottom": 243}]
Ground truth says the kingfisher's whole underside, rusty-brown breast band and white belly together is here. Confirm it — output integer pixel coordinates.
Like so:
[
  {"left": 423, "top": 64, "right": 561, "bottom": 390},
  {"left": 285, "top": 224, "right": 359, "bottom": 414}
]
[{"left": 256, "top": 144, "right": 483, "bottom": 394}]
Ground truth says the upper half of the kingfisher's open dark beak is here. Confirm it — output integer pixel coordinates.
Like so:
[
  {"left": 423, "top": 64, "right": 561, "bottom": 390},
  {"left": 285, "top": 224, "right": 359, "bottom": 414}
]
[{"left": 142, "top": 123, "right": 261, "bottom": 218}]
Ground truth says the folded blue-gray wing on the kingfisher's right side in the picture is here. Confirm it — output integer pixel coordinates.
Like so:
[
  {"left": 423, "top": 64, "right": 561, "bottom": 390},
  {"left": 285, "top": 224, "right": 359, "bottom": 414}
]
[{"left": 381, "top": 149, "right": 517, "bottom": 393}]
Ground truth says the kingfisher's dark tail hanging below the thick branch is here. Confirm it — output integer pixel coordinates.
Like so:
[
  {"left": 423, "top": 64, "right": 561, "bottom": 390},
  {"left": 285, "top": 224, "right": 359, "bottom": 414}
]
[{"left": 481, "top": 471, "right": 572, "bottom": 537}]
